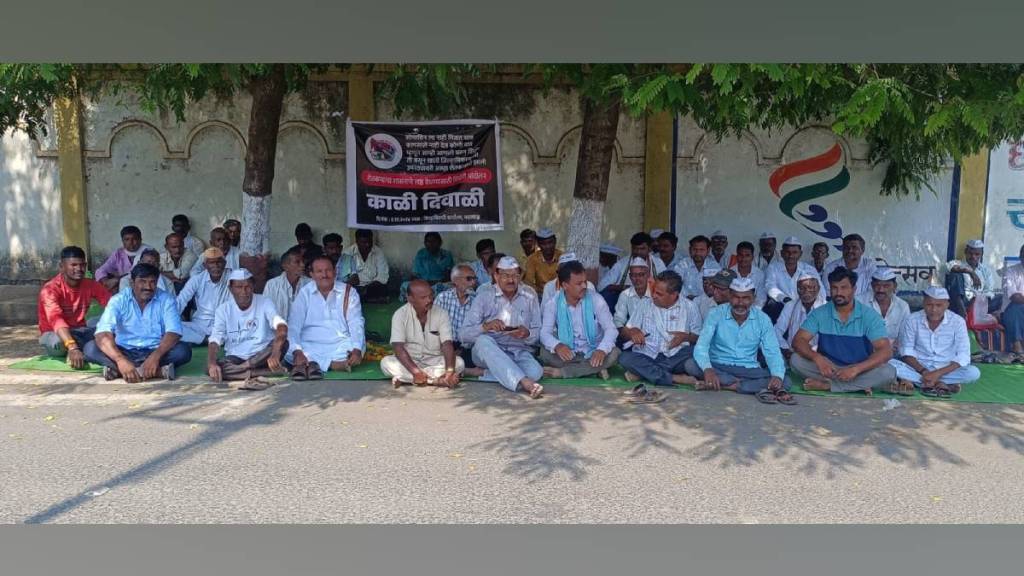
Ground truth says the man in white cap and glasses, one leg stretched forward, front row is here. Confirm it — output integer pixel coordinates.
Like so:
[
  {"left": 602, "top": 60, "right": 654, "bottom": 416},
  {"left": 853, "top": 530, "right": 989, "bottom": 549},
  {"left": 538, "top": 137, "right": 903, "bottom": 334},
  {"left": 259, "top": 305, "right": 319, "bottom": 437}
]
[{"left": 459, "top": 256, "right": 544, "bottom": 398}]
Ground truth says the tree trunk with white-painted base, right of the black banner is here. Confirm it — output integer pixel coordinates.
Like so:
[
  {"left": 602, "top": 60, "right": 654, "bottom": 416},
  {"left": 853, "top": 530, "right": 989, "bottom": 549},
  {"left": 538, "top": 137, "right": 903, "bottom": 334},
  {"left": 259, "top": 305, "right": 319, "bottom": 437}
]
[{"left": 566, "top": 95, "right": 622, "bottom": 284}]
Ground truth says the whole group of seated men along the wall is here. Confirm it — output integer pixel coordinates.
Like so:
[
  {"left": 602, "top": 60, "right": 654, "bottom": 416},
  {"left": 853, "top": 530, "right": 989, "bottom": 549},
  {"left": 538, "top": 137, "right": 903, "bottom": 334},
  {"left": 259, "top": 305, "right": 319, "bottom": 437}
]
[{"left": 39, "top": 216, "right": 1024, "bottom": 404}]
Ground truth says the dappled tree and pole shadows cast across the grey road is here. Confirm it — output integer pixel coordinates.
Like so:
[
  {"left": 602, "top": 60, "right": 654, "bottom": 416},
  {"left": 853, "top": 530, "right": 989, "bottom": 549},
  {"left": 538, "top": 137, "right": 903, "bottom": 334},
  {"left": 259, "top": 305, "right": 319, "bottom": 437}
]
[{"left": 18, "top": 380, "right": 1024, "bottom": 523}]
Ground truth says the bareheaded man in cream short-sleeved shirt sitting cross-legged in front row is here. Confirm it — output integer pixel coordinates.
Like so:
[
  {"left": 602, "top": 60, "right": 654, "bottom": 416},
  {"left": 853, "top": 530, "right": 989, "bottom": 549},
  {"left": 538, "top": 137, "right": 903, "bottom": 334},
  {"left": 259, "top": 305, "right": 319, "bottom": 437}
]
[{"left": 381, "top": 280, "right": 465, "bottom": 388}]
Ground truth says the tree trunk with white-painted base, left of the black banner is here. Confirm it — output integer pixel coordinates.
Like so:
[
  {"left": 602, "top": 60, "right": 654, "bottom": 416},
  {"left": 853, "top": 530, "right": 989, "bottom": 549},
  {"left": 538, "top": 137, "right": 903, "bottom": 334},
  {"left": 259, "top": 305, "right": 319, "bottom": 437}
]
[{"left": 239, "top": 64, "right": 287, "bottom": 292}]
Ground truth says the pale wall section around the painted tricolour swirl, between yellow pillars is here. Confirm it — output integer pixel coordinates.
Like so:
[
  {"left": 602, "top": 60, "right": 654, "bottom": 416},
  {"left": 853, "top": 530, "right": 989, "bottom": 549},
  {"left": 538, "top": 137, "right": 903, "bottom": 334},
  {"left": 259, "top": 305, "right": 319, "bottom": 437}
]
[{"left": 675, "top": 119, "right": 953, "bottom": 290}]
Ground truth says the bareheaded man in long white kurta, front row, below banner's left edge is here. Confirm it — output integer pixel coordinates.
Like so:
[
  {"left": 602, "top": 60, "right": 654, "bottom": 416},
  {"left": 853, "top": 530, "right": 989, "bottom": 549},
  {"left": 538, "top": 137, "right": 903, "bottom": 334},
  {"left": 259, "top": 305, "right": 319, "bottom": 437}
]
[{"left": 285, "top": 254, "right": 367, "bottom": 380}]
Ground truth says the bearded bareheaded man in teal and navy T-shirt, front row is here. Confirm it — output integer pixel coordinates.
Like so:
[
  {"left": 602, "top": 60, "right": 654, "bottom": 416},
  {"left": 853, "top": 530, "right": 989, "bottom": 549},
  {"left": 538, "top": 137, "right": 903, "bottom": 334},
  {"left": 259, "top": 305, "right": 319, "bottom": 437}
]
[{"left": 790, "top": 265, "right": 896, "bottom": 395}]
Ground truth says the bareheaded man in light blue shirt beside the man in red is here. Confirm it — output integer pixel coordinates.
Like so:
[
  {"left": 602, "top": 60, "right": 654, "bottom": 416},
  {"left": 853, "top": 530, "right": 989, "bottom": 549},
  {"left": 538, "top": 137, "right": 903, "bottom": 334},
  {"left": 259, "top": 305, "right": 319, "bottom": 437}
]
[{"left": 83, "top": 263, "right": 191, "bottom": 382}]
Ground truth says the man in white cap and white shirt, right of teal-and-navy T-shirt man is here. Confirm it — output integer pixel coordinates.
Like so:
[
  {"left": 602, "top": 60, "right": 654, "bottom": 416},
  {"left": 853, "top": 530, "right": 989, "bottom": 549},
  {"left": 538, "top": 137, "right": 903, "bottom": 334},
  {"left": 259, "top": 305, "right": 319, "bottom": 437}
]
[{"left": 889, "top": 286, "right": 981, "bottom": 398}]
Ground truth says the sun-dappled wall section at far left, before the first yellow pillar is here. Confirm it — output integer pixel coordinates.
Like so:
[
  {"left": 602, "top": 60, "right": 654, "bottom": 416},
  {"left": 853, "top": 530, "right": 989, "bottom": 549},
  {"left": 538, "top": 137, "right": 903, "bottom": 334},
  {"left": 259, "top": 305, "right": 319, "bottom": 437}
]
[{"left": 0, "top": 132, "right": 63, "bottom": 283}]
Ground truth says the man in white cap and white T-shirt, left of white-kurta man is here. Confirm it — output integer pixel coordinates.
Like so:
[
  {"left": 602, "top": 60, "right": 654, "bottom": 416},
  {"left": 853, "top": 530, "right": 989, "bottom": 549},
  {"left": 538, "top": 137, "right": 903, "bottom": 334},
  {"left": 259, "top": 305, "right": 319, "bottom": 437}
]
[{"left": 206, "top": 269, "right": 288, "bottom": 389}]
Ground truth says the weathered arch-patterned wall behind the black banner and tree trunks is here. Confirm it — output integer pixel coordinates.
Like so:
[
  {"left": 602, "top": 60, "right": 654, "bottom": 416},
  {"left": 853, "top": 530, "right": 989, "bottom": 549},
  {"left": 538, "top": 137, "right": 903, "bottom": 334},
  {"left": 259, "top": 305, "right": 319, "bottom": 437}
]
[{"left": 0, "top": 82, "right": 644, "bottom": 280}]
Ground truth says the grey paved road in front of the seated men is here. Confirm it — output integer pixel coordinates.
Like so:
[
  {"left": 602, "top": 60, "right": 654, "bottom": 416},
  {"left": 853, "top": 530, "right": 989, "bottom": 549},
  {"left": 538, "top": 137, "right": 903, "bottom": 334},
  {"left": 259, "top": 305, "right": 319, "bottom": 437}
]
[{"left": 0, "top": 370, "right": 1024, "bottom": 523}]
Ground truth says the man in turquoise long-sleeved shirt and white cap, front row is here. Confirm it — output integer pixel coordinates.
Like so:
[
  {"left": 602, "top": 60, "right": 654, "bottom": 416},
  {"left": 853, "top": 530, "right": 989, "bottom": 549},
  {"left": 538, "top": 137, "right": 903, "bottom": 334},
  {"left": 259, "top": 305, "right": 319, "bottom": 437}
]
[{"left": 693, "top": 278, "right": 797, "bottom": 405}]
